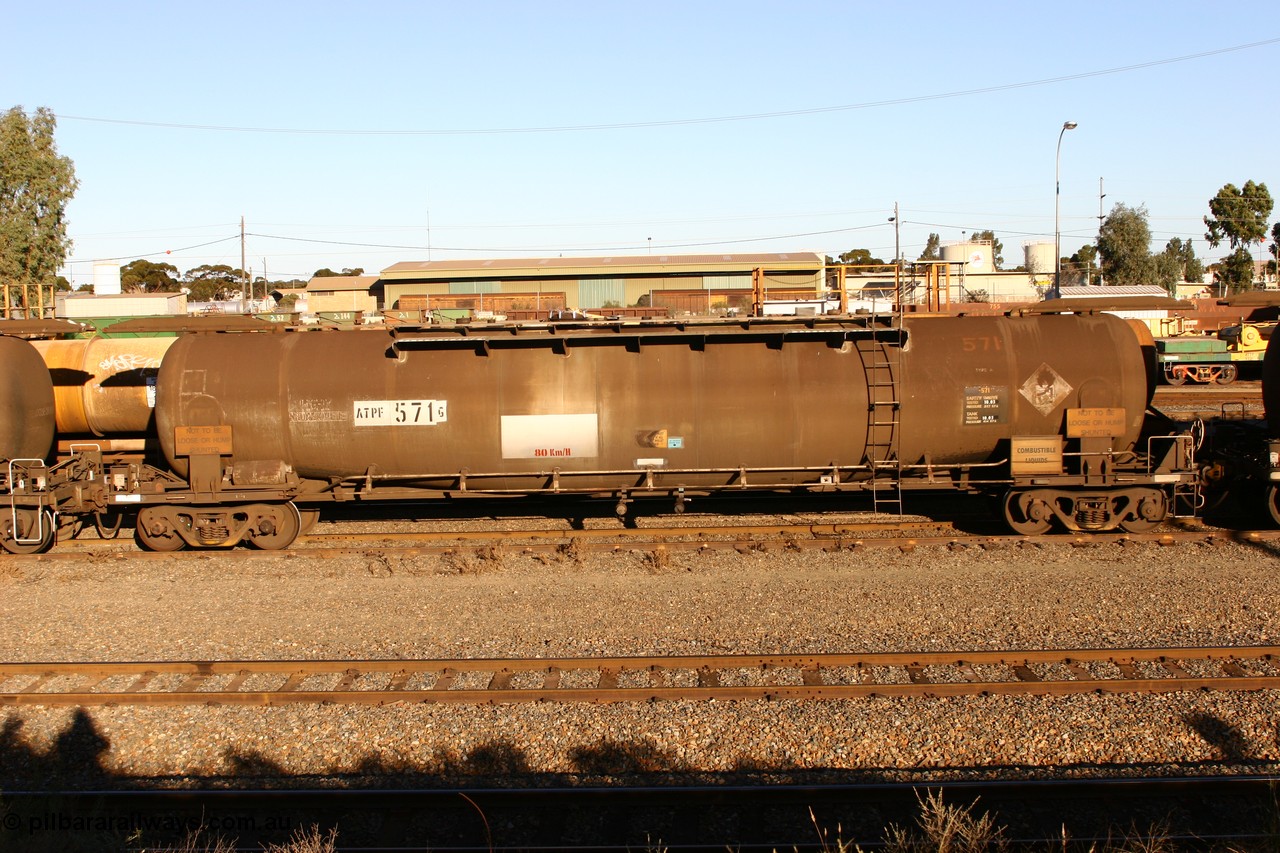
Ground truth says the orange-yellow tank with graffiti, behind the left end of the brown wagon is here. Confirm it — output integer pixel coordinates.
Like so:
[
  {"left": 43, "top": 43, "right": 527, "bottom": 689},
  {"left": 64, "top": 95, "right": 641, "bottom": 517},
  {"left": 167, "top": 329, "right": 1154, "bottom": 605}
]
[{"left": 33, "top": 337, "right": 174, "bottom": 435}]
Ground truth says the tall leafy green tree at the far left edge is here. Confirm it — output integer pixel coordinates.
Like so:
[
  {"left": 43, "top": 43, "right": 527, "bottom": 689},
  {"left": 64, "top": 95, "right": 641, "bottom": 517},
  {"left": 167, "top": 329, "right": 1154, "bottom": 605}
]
[{"left": 0, "top": 106, "right": 79, "bottom": 307}]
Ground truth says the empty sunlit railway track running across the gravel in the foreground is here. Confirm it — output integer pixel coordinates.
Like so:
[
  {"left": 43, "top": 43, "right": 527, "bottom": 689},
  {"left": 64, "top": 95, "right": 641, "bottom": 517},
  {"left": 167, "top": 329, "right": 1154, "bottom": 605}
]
[{"left": 0, "top": 646, "right": 1280, "bottom": 706}]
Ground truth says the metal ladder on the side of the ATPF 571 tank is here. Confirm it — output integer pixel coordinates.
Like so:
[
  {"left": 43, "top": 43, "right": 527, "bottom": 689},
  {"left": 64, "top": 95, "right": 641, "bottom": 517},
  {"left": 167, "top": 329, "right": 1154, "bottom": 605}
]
[{"left": 858, "top": 323, "right": 905, "bottom": 515}]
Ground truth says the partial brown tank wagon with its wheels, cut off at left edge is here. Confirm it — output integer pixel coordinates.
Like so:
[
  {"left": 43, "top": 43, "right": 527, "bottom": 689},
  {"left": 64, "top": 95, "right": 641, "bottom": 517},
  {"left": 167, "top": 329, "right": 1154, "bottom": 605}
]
[{"left": 0, "top": 336, "right": 54, "bottom": 553}]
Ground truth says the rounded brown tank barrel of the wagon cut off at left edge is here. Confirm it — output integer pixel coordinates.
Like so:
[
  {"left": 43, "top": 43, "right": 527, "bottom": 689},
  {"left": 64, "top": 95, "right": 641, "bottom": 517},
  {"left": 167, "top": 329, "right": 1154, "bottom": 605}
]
[{"left": 0, "top": 337, "right": 54, "bottom": 460}]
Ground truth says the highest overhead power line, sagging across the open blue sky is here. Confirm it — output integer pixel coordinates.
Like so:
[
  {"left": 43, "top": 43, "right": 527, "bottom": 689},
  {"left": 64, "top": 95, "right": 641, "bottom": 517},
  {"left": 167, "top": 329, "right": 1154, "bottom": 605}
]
[{"left": 58, "top": 37, "right": 1280, "bottom": 136}]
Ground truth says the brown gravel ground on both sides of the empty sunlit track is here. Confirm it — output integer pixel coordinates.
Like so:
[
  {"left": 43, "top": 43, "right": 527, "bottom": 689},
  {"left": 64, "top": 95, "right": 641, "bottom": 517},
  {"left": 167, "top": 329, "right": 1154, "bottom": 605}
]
[{"left": 0, "top": 499, "right": 1280, "bottom": 849}]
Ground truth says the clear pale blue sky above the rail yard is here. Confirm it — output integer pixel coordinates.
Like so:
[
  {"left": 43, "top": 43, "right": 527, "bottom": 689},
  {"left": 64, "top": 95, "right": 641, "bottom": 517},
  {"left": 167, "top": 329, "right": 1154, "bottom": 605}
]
[{"left": 0, "top": 0, "right": 1280, "bottom": 284}]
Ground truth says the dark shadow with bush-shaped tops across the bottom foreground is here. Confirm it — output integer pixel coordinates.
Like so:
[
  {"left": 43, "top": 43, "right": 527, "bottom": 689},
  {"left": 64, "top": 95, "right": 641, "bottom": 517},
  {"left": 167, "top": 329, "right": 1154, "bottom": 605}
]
[{"left": 0, "top": 710, "right": 1280, "bottom": 852}]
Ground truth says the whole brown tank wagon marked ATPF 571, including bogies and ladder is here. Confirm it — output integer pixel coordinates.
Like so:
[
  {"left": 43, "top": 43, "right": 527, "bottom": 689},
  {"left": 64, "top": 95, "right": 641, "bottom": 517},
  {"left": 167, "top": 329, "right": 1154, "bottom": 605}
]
[{"left": 40, "top": 308, "right": 1177, "bottom": 549}]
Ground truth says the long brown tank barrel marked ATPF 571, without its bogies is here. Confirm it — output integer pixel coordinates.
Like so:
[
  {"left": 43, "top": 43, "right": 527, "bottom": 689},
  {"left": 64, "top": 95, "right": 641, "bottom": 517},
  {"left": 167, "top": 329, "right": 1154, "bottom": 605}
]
[{"left": 156, "top": 315, "right": 1149, "bottom": 489}]
